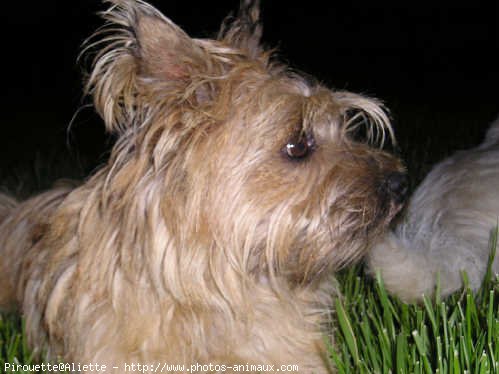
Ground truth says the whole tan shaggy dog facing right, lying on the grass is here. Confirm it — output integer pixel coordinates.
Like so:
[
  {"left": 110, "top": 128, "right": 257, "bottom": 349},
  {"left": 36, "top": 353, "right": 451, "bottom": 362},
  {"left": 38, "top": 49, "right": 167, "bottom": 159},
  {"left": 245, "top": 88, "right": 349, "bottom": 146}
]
[{"left": 0, "top": 0, "right": 406, "bottom": 373}]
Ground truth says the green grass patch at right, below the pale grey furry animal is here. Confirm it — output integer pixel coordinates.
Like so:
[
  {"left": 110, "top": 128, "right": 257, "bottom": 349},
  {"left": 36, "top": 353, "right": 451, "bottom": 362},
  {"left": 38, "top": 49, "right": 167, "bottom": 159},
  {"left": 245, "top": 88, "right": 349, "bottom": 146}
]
[{"left": 330, "top": 231, "right": 499, "bottom": 374}]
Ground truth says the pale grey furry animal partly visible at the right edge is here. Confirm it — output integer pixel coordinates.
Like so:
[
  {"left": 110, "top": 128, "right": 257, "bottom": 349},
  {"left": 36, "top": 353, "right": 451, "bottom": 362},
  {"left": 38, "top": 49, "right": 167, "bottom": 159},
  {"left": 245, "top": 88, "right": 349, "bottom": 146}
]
[{"left": 369, "top": 120, "right": 499, "bottom": 301}]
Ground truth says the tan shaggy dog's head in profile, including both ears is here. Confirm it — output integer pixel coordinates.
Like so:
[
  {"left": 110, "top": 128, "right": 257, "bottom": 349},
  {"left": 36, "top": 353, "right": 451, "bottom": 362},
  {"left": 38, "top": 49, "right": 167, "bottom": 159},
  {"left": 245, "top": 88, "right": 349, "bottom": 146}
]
[{"left": 87, "top": 0, "right": 406, "bottom": 284}]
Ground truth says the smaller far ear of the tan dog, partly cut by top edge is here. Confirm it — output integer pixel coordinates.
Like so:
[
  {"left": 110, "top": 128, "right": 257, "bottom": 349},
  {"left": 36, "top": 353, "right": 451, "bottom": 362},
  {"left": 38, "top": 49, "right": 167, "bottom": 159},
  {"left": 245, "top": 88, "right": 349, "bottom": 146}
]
[{"left": 218, "top": 0, "right": 263, "bottom": 58}]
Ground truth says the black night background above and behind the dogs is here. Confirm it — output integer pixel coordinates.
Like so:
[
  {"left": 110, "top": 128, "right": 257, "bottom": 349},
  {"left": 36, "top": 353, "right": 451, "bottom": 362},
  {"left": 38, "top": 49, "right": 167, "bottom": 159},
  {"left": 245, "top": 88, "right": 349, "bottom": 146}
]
[{"left": 0, "top": 0, "right": 499, "bottom": 191}]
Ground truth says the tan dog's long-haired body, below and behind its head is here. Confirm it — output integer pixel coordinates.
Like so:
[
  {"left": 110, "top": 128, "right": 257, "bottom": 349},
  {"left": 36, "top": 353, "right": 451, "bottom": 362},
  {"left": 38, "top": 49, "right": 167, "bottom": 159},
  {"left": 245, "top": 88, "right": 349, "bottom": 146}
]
[{"left": 0, "top": 186, "right": 335, "bottom": 373}]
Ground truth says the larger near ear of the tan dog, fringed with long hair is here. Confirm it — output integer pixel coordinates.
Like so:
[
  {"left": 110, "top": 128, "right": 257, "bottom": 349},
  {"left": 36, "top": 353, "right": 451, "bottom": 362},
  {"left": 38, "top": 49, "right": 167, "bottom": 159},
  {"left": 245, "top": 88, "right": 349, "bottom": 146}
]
[{"left": 84, "top": 0, "right": 214, "bottom": 133}]
